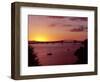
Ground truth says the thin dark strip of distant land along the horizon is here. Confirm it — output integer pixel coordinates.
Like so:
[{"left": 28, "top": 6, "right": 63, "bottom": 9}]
[{"left": 28, "top": 40, "right": 83, "bottom": 44}]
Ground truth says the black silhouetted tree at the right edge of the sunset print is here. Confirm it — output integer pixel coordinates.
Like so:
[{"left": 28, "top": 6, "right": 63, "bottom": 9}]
[{"left": 75, "top": 40, "right": 88, "bottom": 64}]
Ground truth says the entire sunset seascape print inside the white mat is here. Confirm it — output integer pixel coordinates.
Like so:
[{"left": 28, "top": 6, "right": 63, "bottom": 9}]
[{"left": 27, "top": 15, "right": 88, "bottom": 67}]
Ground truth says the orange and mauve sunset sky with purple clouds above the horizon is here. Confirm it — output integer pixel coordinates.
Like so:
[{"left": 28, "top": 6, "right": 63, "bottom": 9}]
[{"left": 28, "top": 15, "right": 88, "bottom": 41}]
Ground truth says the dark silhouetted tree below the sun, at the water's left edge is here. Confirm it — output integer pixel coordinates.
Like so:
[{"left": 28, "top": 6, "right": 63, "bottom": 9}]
[{"left": 28, "top": 45, "right": 40, "bottom": 66}]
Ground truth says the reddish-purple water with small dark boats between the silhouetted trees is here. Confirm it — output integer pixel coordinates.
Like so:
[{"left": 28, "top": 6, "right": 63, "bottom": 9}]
[{"left": 30, "top": 43, "right": 82, "bottom": 66}]
